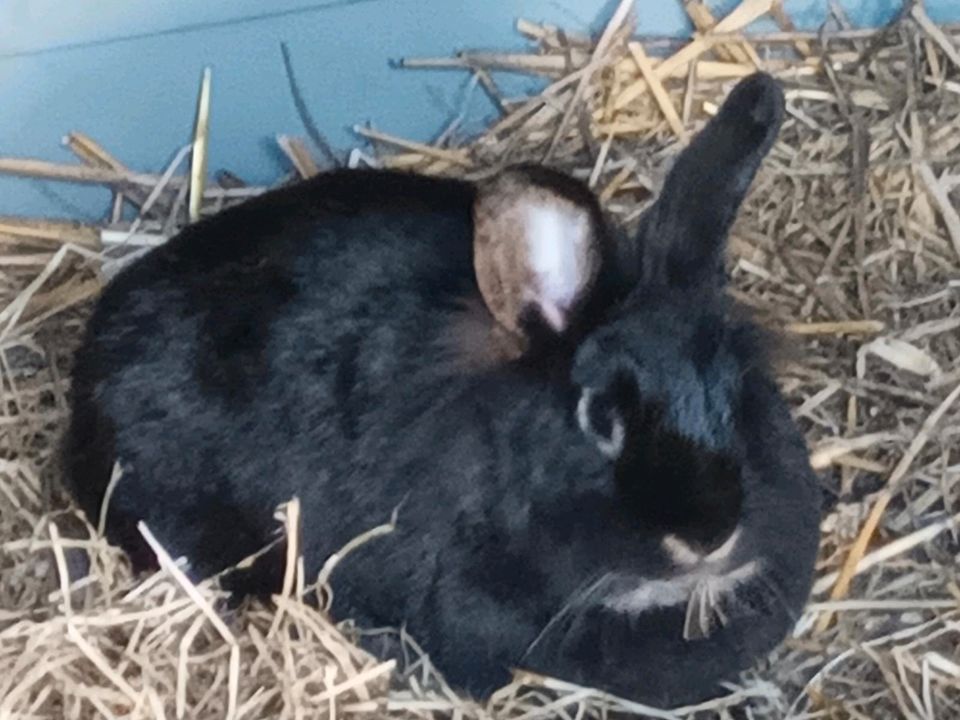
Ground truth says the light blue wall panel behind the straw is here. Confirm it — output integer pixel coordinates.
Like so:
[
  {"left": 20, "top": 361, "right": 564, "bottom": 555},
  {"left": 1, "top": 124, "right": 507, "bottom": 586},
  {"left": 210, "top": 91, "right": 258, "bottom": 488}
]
[{"left": 0, "top": 0, "right": 960, "bottom": 219}]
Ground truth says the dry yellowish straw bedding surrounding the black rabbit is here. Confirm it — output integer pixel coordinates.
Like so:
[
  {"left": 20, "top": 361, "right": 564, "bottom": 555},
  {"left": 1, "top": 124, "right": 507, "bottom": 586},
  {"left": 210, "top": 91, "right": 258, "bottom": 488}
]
[{"left": 0, "top": 0, "right": 960, "bottom": 718}]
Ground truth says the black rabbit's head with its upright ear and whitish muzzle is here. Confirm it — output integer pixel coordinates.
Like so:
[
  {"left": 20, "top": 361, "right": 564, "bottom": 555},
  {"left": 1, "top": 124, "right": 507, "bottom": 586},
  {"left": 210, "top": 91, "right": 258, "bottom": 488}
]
[{"left": 510, "top": 74, "right": 819, "bottom": 705}]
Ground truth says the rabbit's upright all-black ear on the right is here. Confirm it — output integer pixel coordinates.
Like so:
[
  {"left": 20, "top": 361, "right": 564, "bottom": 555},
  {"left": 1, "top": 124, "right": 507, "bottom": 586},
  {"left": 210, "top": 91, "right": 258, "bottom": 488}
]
[{"left": 637, "top": 73, "right": 784, "bottom": 286}]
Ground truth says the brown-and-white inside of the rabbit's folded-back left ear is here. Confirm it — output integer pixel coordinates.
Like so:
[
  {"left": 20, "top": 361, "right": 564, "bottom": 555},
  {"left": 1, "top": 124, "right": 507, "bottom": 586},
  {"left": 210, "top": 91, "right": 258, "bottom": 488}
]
[{"left": 473, "top": 168, "right": 601, "bottom": 339}]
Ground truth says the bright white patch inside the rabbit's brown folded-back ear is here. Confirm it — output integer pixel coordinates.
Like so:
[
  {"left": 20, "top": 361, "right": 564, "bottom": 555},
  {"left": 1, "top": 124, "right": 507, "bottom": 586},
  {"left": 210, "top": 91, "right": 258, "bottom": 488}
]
[{"left": 525, "top": 203, "right": 593, "bottom": 332}]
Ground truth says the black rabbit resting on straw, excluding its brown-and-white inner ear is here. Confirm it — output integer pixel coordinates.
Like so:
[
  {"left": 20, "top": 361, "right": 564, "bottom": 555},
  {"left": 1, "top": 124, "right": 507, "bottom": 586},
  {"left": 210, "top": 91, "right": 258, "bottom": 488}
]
[{"left": 66, "top": 74, "right": 819, "bottom": 705}]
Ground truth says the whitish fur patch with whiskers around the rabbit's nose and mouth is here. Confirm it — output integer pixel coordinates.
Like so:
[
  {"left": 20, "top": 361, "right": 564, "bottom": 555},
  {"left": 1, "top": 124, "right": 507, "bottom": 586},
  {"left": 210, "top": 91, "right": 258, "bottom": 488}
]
[{"left": 604, "top": 528, "right": 761, "bottom": 639}]
